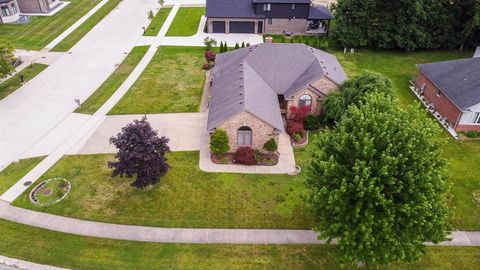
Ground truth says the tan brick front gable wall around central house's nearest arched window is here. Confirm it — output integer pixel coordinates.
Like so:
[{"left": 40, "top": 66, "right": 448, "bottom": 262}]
[{"left": 217, "top": 112, "right": 278, "bottom": 152}]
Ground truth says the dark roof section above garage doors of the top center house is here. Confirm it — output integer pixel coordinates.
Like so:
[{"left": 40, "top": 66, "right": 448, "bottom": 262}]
[{"left": 206, "top": 0, "right": 265, "bottom": 18}]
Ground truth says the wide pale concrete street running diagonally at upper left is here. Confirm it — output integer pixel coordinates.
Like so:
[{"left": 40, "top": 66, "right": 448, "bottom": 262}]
[{"left": 0, "top": 0, "right": 159, "bottom": 170}]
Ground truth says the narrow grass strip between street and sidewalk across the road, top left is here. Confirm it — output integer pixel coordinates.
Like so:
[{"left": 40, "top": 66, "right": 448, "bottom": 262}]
[{"left": 52, "top": 0, "right": 122, "bottom": 52}]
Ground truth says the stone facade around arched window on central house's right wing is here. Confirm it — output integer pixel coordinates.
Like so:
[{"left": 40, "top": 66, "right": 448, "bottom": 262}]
[{"left": 287, "top": 77, "right": 340, "bottom": 119}]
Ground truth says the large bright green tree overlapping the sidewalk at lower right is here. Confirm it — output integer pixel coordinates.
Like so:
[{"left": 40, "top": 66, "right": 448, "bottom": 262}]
[{"left": 306, "top": 92, "right": 451, "bottom": 266}]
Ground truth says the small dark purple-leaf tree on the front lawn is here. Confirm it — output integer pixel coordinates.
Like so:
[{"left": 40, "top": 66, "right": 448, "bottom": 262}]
[{"left": 108, "top": 116, "right": 170, "bottom": 188}]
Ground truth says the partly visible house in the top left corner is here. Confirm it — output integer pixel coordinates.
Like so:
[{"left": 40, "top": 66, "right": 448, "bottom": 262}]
[{"left": 0, "top": 0, "right": 61, "bottom": 23}]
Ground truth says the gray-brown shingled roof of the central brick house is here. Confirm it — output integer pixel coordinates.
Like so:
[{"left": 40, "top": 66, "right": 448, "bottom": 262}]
[{"left": 207, "top": 44, "right": 347, "bottom": 131}]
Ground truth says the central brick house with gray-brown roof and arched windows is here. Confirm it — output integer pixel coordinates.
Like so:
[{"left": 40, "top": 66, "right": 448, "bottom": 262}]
[{"left": 207, "top": 43, "right": 347, "bottom": 151}]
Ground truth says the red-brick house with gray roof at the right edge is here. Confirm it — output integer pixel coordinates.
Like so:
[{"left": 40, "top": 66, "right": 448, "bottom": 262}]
[{"left": 415, "top": 53, "right": 480, "bottom": 132}]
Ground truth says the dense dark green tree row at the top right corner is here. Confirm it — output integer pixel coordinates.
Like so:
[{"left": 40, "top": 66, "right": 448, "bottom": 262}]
[{"left": 333, "top": 0, "right": 480, "bottom": 51}]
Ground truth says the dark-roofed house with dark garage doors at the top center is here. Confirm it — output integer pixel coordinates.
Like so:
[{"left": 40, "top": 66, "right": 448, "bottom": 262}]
[{"left": 206, "top": 0, "right": 333, "bottom": 34}]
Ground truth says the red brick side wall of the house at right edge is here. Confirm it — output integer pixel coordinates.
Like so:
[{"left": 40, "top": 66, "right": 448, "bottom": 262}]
[{"left": 415, "top": 70, "right": 462, "bottom": 129}]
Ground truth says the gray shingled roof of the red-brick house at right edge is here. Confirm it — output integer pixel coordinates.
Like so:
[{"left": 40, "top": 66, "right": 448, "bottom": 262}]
[{"left": 418, "top": 58, "right": 480, "bottom": 110}]
